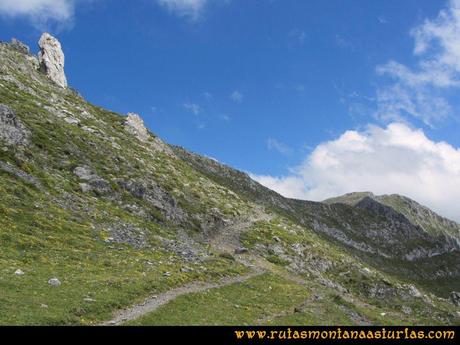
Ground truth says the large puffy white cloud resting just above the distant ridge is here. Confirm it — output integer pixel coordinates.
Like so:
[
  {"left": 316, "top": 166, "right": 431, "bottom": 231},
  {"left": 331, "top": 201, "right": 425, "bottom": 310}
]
[{"left": 252, "top": 123, "right": 460, "bottom": 221}]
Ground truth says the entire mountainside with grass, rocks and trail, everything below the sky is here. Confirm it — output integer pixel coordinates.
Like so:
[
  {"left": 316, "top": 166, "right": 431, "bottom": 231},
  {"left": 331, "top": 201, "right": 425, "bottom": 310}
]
[{"left": 0, "top": 34, "right": 460, "bottom": 325}]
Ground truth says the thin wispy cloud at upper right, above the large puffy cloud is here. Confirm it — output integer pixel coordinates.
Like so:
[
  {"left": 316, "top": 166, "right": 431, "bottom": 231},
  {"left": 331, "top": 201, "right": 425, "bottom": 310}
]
[{"left": 376, "top": 0, "right": 460, "bottom": 126}]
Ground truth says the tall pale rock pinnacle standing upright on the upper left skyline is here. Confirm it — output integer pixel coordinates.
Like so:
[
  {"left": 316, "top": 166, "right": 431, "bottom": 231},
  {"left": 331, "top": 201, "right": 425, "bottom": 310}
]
[{"left": 38, "top": 32, "right": 67, "bottom": 88}]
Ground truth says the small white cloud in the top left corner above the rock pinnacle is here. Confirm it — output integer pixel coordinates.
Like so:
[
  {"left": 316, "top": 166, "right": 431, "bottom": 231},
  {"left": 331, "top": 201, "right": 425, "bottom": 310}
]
[{"left": 0, "top": 0, "right": 77, "bottom": 26}]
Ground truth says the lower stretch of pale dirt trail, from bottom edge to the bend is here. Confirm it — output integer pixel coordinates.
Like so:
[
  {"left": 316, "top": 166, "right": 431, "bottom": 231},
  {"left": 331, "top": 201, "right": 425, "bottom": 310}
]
[{"left": 101, "top": 269, "right": 264, "bottom": 326}]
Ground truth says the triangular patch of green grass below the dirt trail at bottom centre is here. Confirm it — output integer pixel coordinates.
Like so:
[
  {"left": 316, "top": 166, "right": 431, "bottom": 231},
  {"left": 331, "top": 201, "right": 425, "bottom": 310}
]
[{"left": 130, "top": 274, "right": 403, "bottom": 325}]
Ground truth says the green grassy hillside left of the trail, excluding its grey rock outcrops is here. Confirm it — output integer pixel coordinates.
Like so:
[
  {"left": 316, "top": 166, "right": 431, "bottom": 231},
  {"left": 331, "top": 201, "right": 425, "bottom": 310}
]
[{"left": 0, "top": 44, "right": 249, "bottom": 324}]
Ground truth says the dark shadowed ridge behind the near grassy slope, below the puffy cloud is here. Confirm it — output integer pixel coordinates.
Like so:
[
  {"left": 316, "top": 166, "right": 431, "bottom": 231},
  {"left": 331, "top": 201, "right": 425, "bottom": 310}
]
[{"left": 174, "top": 147, "right": 460, "bottom": 282}]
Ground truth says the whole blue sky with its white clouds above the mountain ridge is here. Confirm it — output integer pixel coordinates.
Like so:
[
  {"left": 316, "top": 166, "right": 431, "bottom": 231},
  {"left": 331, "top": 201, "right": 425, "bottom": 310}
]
[{"left": 0, "top": 0, "right": 460, "bottom": 220}]
